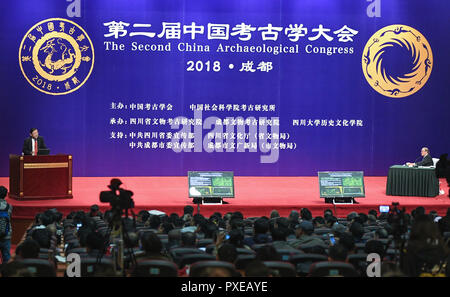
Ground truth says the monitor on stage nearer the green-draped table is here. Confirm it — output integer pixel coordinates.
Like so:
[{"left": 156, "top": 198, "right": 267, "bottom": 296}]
[{"left": 318, "top": 171, "right": 365, "bottom": 198}]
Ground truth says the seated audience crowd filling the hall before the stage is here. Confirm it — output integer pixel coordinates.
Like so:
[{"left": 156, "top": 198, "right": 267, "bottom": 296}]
[{"left": 2, "top": 205, "right": 450, "bottom": 277}]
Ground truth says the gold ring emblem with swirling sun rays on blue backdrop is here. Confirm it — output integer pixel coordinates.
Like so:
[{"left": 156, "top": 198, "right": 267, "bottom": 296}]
[{"left": 362, "top": 25, "right": 433, "bottom": 98}]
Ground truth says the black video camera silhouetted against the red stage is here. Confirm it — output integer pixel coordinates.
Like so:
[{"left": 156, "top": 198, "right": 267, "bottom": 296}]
[{"left": 100, "top": 178, "right": 134, "bottom": 214}]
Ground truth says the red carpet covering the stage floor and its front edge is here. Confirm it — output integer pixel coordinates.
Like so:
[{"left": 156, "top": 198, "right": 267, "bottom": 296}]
[{"left": 0, "top": 177, "right": 450, "bottom": 219}]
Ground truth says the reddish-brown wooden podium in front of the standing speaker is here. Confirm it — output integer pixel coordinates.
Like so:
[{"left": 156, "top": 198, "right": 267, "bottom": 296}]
[{"left": 9, "top": 155, "right": 73, "bottom": 200}]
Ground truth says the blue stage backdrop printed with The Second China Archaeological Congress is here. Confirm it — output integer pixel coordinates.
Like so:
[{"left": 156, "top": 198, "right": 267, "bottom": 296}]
[{"left": 0, "top": 0, "right": 450, "bottom": 176}]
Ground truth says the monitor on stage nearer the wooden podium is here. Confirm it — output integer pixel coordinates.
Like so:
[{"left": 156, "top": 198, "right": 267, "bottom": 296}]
[{"left": 188, "top": 171, "right": 234, "bottom": 198}]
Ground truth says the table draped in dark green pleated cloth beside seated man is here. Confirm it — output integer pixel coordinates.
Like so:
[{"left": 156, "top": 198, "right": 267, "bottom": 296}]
[{"left": 386, "top": 165, "right": 439, "bottom": 197}]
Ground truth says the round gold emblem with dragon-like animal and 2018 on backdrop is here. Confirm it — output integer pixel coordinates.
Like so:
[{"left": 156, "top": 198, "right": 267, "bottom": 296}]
[{"left": 19, "top": 18, "right": 94, "bottom": 95}]
